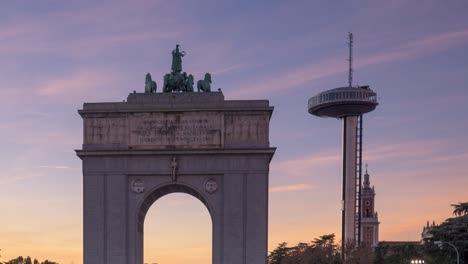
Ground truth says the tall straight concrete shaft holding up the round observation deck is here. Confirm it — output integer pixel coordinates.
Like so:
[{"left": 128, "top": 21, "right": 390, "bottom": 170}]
[{"left": 342, "top": 116, "right": 358, "bottom": 245}]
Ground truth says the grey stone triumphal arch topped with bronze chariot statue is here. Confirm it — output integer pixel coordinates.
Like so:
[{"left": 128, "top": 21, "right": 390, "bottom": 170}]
[{"left": 77, "top": 44, "right": 275, "bottom": 264}]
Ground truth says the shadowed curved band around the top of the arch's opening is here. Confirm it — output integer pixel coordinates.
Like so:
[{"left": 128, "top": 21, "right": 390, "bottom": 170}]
[{"left": 138, "top": 183, "right": 213, "bottom": 232}]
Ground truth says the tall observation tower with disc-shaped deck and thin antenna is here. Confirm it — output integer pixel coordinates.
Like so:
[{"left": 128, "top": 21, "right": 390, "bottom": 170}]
[{"left": 308, "top": 33, "right": 378, "bottom": 254}]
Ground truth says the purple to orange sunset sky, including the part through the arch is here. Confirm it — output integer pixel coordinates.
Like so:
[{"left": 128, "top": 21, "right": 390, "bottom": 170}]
[{"left": 0, "top": 0, "right": 468, "bottom": 264}]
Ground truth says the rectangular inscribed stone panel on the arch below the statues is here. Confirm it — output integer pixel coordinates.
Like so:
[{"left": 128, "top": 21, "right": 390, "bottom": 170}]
[{"left": 129, "top": 112, "right": 224, "bottom": 149}]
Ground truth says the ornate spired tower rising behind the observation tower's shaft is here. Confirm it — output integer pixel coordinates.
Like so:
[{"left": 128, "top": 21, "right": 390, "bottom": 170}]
[{"left": 361, "top": 168, "right": 380, "bottom": 247}]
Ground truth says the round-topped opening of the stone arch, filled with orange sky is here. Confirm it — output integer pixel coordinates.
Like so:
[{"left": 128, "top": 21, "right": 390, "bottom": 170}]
[{"left": 143, "top": 192, "right": 213, "bottom": 264}]
